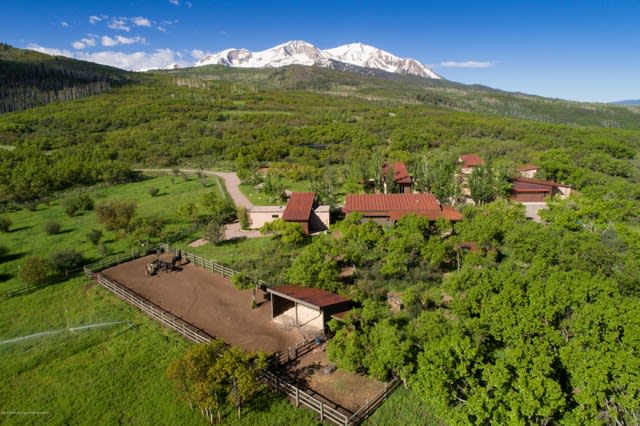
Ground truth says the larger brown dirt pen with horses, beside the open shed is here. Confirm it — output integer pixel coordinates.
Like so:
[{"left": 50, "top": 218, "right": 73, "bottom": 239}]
[{"left": 102, "top": 255, "right": 302, "bottom": 352}]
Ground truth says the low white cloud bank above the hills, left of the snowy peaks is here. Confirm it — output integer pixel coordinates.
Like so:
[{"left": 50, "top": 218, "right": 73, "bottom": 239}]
[{"left": 27, "top": 44, "right": 190, "bottom": 71}]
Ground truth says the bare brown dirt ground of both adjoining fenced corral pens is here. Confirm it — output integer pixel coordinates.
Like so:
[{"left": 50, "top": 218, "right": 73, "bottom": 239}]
[{"left": 102, "top": 254, "right": 384, "bottom": 414}]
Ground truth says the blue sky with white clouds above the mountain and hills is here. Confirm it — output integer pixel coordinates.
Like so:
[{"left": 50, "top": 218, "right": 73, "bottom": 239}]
[{"left": 0, "top": 0, "right": 640, "bottom": 102}]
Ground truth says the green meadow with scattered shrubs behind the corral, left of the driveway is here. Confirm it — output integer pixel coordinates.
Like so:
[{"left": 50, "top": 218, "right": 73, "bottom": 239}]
[{"left": 0, "top": 176, "right": 212, "bottom": 294}]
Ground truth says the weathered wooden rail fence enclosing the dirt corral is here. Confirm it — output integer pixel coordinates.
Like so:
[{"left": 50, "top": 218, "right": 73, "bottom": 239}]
[{"left": 83, "top": 243, "right": 400, "bottom": 426}]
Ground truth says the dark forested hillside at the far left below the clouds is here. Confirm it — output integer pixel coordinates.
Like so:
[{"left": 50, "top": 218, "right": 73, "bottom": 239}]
[{"left": 0, "top": 43, "right": 128, "bottom": 114}]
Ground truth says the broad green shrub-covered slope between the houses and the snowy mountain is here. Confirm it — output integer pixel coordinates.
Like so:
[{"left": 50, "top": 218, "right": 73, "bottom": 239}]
[{"left": 0, "top": 65, "right": 640, "bottom": 206}]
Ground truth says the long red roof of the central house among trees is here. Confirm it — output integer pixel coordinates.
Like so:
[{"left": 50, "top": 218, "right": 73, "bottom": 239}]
[{"left": 342, "top": 193, "right": 463, "bottom": 223}]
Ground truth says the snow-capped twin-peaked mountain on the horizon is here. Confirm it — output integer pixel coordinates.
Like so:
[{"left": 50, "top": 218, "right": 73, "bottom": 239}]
[{"left": 194, "top": 40, "right": 440, "bottom": 79}]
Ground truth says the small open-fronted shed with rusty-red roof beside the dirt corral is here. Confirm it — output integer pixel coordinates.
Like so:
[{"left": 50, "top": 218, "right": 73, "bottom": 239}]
[{"left": 267, "top": 286, "right": 352, "bottom": 331}]
